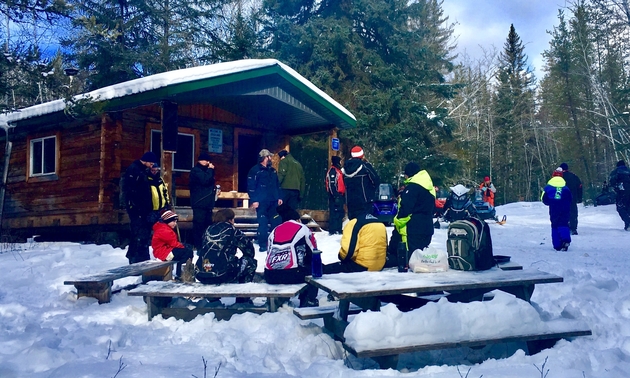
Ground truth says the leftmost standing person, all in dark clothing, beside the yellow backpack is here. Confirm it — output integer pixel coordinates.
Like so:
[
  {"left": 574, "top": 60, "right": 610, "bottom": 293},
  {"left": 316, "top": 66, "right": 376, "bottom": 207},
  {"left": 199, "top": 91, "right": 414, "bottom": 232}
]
[{"left": 120, "top": 151, "right": 158, "bottom": 264}]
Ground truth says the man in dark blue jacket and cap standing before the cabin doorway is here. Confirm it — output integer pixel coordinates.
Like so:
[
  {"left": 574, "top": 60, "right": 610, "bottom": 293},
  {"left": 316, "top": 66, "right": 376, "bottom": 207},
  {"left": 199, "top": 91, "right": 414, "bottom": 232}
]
[{"left": 247, "top": 149, "right": 282, "bottom": 252}]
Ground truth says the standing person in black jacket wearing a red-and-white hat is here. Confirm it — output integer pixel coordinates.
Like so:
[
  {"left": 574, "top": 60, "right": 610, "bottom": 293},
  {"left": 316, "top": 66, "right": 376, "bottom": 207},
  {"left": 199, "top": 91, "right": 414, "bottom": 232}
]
[{"left": 342, "top": 146, "right": 380, "bottom": 219}]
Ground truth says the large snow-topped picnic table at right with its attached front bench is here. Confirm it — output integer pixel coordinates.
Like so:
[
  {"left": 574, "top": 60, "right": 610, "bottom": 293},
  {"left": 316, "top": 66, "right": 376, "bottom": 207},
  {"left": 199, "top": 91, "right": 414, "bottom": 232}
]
[{"left": 306, "top": 268, "right": 591, "bottom": 368}]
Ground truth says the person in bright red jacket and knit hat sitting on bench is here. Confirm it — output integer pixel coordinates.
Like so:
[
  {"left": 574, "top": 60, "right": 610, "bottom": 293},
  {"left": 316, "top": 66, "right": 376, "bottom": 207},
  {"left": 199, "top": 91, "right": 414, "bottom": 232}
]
[{"left": 151, "top": 210, "right": 194, "bottom": 280}]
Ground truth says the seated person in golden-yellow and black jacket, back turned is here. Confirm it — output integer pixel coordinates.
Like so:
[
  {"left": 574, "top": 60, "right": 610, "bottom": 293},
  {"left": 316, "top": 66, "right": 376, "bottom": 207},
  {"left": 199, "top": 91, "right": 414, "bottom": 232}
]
[{"left": 324, "top": 214, "right": 387, "bottom": 274}]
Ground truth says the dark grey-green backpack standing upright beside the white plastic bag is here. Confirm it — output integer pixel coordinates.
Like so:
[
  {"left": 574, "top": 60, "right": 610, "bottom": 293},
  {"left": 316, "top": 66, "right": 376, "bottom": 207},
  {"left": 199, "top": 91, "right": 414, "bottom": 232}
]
[{"left": 446, "top": 217, "right": 495, "bottom": 270}]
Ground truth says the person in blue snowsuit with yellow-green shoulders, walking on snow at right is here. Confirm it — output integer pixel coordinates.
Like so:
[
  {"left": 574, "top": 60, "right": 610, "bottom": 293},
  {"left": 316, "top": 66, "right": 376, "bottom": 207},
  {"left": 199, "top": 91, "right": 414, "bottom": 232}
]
[{"left": 540, "top": 167, "right": 573, "bottom": 251}]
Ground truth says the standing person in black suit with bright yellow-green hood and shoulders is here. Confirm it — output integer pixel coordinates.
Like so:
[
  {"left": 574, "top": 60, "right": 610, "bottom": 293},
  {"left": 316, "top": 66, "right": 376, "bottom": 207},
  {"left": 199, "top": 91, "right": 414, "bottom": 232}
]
[{"left": 392, "top": 162, "right": 435, "bottom": 255}]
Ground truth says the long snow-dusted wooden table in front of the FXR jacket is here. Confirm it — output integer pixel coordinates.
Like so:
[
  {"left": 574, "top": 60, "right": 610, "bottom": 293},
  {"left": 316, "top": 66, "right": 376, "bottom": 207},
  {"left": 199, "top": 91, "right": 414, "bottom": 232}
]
[{"left": 128, "top": 281, "right": 307, "bottom": 321}]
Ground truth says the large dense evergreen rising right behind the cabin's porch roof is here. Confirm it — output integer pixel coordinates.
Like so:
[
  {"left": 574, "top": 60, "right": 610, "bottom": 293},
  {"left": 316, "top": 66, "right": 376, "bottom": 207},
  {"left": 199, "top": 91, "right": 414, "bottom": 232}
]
[{"left": 263, "top": 0, "right": 454, "bottom": 182}]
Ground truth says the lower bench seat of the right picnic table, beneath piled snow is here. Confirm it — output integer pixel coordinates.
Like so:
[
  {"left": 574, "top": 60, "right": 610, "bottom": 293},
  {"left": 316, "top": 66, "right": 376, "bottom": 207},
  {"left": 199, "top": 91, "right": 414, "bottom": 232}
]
[{"left": 343, "top": 320, "right": 592, "bottom": 369}]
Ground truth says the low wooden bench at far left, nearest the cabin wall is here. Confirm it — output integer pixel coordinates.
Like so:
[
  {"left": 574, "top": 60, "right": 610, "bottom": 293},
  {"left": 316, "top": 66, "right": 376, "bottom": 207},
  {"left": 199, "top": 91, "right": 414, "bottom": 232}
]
[{"left": 63, "top": 260, "right": 174, "bottom": 303}]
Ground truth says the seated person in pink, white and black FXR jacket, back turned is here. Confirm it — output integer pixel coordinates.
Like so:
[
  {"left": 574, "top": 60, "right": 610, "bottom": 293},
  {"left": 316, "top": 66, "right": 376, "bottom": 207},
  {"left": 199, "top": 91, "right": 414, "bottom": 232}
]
[{"left": 265, "top": 203, "right": 319, "bottom": 307}]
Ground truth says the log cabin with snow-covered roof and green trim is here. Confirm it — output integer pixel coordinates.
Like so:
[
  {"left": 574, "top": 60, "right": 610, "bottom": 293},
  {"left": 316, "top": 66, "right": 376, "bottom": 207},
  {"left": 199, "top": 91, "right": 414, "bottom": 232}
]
[{"left": 0, "top": 59, "right": 356, "bottom": 246}]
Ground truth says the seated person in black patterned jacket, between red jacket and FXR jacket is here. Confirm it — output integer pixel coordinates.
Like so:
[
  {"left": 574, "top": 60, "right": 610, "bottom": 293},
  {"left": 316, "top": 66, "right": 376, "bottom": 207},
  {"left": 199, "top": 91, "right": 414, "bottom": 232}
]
[{"left": 195, "top": 209, "right": 257, "bottom": 305}]
